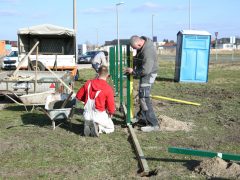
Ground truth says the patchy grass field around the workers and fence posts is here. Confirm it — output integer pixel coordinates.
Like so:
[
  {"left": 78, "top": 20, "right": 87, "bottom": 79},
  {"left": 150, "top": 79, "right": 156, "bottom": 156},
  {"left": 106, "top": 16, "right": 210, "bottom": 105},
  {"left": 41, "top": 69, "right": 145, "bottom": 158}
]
[{"left": 0, "top": 61, "right": 240, "bottom": 179}]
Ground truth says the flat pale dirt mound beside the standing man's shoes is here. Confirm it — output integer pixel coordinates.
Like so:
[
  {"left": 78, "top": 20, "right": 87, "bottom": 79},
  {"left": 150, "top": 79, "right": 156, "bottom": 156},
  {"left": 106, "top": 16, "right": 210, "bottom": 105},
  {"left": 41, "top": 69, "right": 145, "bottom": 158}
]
[{"left": 159, "top": 115, "right": 193, "bottom": 131}]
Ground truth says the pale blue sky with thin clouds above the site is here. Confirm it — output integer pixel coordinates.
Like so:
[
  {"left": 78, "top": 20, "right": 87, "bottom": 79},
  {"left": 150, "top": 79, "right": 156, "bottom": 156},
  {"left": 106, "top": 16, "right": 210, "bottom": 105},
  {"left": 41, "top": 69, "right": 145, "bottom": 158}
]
[{"left": 0, "top": 0, "right": 240, "bottom": 45}]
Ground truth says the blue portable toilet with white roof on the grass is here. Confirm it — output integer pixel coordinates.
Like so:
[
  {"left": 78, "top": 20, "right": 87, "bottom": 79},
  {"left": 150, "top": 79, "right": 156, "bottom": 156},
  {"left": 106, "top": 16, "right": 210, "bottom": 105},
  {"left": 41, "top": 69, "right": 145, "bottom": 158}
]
[{"left": 174, "top": 30, "right": 211, "bottom": 83}]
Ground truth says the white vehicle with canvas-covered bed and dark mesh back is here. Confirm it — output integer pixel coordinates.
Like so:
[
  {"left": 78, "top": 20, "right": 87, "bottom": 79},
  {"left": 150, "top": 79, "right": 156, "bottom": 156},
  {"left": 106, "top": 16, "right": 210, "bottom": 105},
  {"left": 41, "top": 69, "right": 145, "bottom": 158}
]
[{"left": 17, "top": 24, "right": 78, "bottom": 76}]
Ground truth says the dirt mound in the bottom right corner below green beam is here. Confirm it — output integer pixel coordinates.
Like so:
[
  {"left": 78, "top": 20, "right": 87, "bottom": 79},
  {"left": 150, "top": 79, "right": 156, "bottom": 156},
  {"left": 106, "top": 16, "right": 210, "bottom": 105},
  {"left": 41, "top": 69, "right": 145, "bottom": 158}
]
[{"left": 194, "top": 157, "right": 240, "bottom": 179}]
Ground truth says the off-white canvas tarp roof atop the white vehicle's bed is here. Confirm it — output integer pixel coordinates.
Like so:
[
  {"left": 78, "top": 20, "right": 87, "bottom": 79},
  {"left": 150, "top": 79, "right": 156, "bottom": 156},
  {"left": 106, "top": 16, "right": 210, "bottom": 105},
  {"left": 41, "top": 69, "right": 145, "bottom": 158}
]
[{"left": 18, "top": 24, "right": 75, "bottom": 36}]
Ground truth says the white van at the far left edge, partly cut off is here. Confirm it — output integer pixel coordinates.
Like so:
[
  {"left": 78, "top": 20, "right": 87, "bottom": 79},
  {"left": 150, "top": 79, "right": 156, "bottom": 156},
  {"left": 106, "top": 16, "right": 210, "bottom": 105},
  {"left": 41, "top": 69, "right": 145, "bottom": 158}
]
[{"left": 2, "top": 47, "right": 19, "bottom": 69}]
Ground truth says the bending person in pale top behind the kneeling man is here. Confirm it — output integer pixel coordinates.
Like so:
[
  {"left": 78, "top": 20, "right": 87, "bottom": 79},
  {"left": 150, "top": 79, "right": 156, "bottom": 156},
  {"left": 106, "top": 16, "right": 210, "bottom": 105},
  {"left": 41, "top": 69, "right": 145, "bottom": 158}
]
[{"left": 92, "top": 51, "right": 108, "bottom": 72}]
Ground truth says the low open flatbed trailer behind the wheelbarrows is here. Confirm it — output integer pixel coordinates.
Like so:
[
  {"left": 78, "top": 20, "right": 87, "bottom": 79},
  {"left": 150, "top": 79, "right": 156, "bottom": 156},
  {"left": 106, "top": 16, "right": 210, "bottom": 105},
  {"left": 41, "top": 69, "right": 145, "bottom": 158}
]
[{"left": 0, "top": 70, "right": 74, "bottom": 96}]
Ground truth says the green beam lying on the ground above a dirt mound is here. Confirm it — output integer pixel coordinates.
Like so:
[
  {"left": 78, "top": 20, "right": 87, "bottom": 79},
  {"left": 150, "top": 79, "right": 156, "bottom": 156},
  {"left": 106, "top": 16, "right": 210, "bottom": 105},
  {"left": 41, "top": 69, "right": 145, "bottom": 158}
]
[{"left": 168, "top": 147, "right": 240, "bottom": 161}]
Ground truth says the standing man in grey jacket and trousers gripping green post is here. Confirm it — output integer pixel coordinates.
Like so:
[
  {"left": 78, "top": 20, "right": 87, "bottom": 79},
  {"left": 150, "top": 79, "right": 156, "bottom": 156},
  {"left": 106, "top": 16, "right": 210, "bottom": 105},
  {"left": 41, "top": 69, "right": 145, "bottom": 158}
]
[{"left": 125, "top": 36, "right": 159, "bottom": 132}]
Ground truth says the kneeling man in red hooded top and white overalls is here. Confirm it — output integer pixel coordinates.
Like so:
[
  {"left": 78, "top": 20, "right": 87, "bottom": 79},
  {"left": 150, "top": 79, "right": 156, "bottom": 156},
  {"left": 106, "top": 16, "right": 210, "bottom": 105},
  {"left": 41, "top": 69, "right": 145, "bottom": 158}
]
[{"left": 76, "top": 65, "right": 115, "bottom": 136}]
